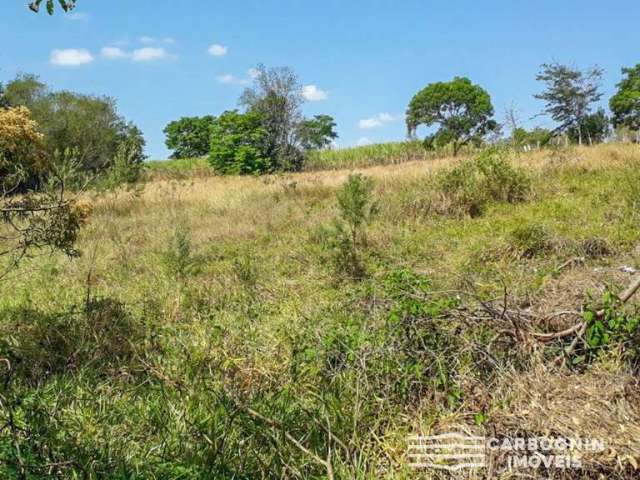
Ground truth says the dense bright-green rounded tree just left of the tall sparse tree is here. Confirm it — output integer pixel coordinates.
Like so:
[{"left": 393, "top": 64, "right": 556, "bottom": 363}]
[{"left": 209, "top": 111, "right": 273, "bottom": 175}]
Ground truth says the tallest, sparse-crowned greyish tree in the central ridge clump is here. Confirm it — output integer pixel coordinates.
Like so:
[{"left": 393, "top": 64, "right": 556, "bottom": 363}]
[{"left": 240, "top": 65, "right": 304, "bottom": 170}]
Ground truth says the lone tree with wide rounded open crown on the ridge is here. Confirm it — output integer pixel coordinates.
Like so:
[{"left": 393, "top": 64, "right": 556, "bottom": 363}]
[{"left": 407, "top": 77, "right": 498, "bottom": 155}]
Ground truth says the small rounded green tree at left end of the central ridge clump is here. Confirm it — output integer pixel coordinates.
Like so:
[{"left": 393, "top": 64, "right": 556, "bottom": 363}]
[{"left": 164, "top": 115, "right": 215, "bottom": 158}]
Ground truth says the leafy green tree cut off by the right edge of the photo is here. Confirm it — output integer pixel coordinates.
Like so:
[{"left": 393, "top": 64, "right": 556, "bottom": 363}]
[{"left": 609, "top": 64, "right": 640, "bottom": 142}]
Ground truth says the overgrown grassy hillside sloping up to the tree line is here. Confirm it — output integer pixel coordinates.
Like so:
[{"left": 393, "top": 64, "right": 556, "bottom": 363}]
[{"left": 0, "top": 145, "right": 640, "bottom": 479}]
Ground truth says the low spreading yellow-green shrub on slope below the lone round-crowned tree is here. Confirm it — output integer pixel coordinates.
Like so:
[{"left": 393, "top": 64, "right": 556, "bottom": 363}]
[{"left": 436, "top": 149, "right": 531, "bottom": 217}]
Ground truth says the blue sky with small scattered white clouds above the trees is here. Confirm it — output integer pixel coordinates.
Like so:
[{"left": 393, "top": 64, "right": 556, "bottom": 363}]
[{"left": 0, "top": 0, "right": 640, "bottom": 158}]
